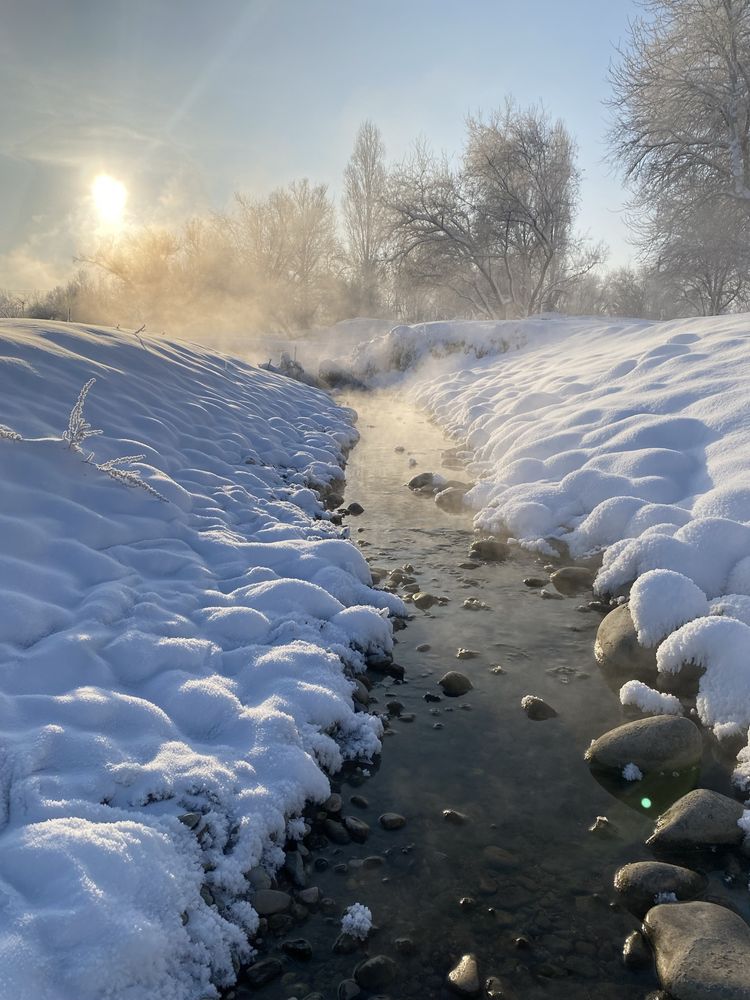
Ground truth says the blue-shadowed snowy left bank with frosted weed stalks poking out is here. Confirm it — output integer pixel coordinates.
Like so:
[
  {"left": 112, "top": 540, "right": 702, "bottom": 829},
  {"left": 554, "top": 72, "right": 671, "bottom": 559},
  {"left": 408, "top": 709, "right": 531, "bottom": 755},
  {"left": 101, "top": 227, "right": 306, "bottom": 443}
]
[{"left": 0, "top": 322, "right": 403, "bottom": 1000}]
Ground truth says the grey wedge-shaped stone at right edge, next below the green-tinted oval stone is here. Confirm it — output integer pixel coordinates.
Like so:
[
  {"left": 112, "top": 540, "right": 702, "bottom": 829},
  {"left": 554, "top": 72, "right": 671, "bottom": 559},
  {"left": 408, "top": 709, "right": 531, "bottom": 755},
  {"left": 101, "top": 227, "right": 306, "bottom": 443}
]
[{"left": 646, "top": 788, "right": 744, "bottom": 848}]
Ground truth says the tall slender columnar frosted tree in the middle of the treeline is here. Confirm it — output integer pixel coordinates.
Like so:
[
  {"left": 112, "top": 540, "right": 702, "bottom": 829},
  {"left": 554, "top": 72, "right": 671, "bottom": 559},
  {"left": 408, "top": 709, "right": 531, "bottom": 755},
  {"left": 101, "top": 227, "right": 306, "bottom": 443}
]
[{"left": 341, "top": 121, "right": 388, "bottom": 314}]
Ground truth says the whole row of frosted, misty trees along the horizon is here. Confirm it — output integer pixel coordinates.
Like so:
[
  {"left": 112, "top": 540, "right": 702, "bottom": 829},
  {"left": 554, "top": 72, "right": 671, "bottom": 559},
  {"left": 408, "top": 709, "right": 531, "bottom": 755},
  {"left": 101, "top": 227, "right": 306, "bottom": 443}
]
[{"left": 8, "top": 0, "right": 750, "bottom": 333}]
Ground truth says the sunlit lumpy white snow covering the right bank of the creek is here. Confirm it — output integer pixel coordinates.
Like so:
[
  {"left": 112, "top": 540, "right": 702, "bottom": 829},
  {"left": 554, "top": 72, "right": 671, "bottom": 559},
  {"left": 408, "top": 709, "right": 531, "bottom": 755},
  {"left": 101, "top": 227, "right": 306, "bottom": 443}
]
[{"left": 351, "top": 315, "right": 750, "bottom": 789}]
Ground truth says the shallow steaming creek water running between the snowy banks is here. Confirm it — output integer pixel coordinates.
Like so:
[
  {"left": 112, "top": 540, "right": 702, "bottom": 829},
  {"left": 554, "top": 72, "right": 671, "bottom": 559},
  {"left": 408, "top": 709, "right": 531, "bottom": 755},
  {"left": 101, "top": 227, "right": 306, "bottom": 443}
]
[{"left": 232, "top": 394, "right": 748, "bottom": 1000}]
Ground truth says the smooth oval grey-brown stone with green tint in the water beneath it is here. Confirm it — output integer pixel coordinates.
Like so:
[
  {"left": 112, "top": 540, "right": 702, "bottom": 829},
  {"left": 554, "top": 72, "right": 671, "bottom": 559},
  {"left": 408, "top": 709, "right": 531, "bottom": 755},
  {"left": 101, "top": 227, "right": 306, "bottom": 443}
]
[{"left": 585, "top": 715, "right": 703, "bottom": 774}]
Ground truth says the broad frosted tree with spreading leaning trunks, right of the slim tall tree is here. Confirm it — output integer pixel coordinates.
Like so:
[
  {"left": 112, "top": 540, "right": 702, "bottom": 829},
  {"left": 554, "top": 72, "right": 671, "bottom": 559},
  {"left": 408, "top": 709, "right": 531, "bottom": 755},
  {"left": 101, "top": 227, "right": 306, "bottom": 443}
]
[{"left": 388, "top": 101, "right": 600, "bottom": 318}]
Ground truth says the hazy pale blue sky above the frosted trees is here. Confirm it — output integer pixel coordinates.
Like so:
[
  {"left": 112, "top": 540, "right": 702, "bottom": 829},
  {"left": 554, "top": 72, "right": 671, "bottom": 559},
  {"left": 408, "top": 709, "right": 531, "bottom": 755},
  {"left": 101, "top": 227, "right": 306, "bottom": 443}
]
[{"left": 0, "top": 0, "right": 637, "bottom": 291}]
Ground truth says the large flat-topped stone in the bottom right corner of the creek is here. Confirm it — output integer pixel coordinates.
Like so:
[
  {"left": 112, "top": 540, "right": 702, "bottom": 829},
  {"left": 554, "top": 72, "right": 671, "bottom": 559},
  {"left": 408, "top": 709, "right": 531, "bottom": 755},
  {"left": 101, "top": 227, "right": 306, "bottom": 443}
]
[{"left": 643, "top": 902, "right": 750, "bottom": 1000}]
